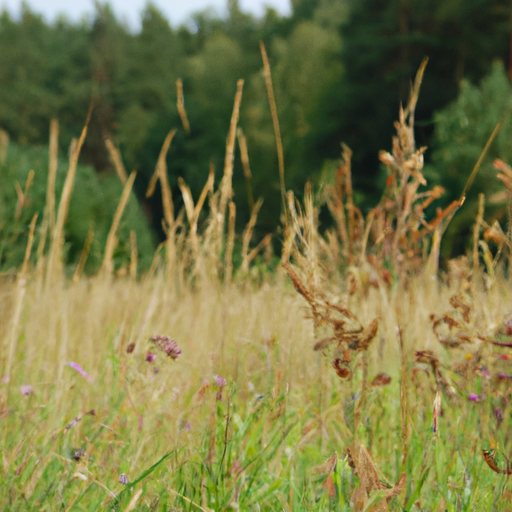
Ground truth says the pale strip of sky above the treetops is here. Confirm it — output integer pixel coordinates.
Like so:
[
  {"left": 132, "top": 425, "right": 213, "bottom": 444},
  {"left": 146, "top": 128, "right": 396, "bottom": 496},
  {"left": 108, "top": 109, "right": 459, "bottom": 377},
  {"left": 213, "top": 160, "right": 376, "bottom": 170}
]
[{"left": 0, "top": 0, "right": 290, "bottom": 29}]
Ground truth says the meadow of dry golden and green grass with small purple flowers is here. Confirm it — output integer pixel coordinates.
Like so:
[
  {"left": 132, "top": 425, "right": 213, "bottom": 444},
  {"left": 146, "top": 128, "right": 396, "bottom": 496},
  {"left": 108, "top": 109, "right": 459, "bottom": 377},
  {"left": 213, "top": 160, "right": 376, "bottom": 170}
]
[{"left": 0, "top": 62, "right": 512, "bottom": 512}]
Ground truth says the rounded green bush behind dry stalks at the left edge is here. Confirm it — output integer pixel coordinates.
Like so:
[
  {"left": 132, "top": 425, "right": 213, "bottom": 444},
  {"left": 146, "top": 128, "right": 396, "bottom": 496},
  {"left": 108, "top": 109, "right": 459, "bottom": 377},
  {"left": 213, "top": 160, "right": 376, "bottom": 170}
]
[{"left": 0, "top": 140, "right": 155, "bottom": 272}]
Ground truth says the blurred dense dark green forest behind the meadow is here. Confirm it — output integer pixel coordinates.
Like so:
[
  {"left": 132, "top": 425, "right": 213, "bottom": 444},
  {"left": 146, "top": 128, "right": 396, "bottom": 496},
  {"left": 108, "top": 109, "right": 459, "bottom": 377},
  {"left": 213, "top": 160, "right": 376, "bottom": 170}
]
[{"left": 0, "top": 0, "right": 512, "bottom": 272}]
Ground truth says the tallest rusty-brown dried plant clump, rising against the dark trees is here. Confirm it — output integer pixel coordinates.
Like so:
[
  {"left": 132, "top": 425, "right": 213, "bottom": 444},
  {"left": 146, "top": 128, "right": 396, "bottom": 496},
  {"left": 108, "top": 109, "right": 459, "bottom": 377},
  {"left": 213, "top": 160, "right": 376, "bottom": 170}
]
[{"left": 316, "top": 59, "right": 463, "bottom": 283}]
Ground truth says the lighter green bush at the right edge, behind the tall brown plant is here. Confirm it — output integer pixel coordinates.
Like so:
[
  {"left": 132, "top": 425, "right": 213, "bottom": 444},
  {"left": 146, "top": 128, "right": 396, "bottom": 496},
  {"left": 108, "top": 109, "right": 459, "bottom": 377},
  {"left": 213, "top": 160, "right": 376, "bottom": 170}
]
[{"left": 427, "top": 62, "right": 512, "bottom": 255}]
